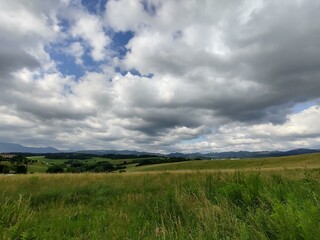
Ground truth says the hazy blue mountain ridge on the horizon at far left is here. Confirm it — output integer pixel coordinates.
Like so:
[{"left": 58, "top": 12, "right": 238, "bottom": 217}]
[{"left": 0, "top": 143, "right": 60, "bottom": 153}]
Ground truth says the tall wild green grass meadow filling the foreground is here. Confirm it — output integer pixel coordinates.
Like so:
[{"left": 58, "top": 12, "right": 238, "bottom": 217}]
[{"left": 0, "top": 169, "right": 320, "bottom": 240}]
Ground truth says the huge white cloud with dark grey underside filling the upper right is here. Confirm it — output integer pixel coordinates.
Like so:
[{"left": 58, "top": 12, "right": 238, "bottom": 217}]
[{"left": 109, "top": 1, "right": 319, "bottom": 121}]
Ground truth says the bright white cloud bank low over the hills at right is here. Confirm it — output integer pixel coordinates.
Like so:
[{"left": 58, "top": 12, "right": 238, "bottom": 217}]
[{"left": 177, "top": 106, "right": 320, "bottom": 152}]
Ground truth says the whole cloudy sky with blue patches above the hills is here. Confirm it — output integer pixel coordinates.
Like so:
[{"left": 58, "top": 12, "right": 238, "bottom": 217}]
[{"left": 0, "top": 0, "right": 320, "bottom": 153}]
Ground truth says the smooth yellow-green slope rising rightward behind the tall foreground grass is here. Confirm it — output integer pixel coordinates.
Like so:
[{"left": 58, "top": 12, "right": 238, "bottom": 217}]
[{"left": 130, "top": 153, "right": 320, "bottom": 172}]
